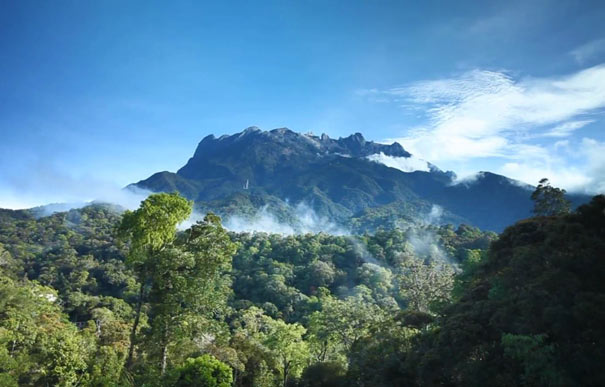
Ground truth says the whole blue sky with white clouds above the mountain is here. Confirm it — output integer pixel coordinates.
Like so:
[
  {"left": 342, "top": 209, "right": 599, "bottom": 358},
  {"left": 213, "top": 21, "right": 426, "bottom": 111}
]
[{"left": 0, "top": 0, "right": 605, "bottom": 208}]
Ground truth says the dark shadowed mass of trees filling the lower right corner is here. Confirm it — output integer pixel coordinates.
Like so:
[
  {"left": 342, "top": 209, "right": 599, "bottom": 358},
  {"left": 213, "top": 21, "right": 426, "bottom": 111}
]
[{"left": 410, "top": 196, "right": 605, "bottom": 386}]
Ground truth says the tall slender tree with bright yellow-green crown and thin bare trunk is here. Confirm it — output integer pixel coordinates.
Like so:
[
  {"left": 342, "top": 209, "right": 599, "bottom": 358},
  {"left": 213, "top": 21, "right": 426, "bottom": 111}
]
[{"left": 118, "top": 193, "right": 192, "bottom": 367}]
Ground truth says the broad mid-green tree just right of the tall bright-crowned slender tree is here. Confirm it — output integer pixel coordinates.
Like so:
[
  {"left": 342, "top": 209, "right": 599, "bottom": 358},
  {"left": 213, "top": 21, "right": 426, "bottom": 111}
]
[{"left": 149, "top": 214, "right": 236, "bottom": 374}]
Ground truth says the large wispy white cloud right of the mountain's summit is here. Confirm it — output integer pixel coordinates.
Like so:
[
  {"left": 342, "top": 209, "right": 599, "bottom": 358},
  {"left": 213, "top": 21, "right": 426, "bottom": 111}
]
[{"left": 358, "top": 65, "right": 605, "bottom": 193}]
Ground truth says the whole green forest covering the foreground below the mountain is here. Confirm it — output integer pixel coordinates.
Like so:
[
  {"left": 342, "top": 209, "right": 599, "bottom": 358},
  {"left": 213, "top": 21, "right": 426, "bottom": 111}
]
[{"left": 0, "top": 184, "right": 605, "bottom": 387}]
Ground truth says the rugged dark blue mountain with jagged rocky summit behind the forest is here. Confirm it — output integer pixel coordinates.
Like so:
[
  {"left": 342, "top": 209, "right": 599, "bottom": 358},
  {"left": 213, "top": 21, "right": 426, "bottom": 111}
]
[{"left": 129, "top": 127, "right": 587, "bottom": 232}]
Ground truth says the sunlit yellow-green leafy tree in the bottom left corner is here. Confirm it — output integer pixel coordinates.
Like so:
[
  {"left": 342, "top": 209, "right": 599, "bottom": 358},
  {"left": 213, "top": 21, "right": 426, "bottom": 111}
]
[{"left": 0, "top": 275, "right": 94, "bottom": 386}]
